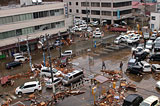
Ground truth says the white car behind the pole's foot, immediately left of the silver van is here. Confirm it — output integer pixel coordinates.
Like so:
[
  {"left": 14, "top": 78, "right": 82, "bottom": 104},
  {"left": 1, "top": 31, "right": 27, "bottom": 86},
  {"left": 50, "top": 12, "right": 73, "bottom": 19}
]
[{"left": 45, "top": 77, "right": 62, "bottom": 88}]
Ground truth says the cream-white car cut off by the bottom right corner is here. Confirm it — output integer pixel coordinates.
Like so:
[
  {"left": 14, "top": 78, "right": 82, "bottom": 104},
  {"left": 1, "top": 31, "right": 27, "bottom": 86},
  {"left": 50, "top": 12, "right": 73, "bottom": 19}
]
[{"left": 139, "top": 95, "right": 159, "bottom": 106}]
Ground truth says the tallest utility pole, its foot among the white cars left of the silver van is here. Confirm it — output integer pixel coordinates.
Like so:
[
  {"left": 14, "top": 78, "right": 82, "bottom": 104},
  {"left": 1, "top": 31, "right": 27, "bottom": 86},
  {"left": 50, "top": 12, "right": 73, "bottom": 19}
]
[{"left": 45, "top": 34, "right": 54, "bottom": 83}]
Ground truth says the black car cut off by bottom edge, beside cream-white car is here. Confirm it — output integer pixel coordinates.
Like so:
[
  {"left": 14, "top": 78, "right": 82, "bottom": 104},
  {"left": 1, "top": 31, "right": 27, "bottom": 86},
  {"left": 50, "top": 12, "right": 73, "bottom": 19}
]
[{"left": 122, "top": 94, "right": 143, "bottom": 106}]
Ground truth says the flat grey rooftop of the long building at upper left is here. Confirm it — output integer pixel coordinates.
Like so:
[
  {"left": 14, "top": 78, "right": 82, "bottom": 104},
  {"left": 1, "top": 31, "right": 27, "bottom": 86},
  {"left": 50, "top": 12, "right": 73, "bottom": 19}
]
[{"left": 0, "top": 1, "right": 60, "bottom": 10}]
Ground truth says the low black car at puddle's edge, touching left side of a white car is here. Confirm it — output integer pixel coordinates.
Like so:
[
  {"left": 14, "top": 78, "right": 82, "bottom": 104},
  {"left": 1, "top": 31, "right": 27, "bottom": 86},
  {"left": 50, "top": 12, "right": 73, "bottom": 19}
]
[{"left": 126, "top": 65, "right": 143, "bottom": 74}]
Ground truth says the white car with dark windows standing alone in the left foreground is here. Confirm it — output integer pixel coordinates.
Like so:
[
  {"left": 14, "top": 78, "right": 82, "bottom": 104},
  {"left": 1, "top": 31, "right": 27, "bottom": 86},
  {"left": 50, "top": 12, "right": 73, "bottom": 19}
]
[{"left": 15, "top": 81, "right": 42, "bottom": 95}]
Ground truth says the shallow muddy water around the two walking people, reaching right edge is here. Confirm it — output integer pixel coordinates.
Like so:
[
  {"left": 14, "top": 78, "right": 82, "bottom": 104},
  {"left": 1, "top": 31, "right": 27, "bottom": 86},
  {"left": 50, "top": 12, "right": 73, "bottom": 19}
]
[{"left": 73, "top": 49, "right": 160, "bottom": 98}]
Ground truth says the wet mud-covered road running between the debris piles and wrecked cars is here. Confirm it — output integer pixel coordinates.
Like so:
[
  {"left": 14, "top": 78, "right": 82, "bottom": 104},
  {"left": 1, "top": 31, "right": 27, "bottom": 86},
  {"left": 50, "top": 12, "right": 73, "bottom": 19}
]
[{"left": 0, "top": 32, "right": 160, "bottom": 106}]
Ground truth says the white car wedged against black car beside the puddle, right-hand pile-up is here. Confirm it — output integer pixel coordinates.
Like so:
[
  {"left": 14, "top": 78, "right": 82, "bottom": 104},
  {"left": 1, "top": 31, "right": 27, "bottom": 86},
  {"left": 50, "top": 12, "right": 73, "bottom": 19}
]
[{"left": 138, "top": 61, "right": 151, "bottom": 72}]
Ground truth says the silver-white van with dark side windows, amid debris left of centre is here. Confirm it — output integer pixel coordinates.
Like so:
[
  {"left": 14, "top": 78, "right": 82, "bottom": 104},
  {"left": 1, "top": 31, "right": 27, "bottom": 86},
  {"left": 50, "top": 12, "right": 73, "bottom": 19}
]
[{"left": 62, "top": 70, "right": 84, "bottom": 85}]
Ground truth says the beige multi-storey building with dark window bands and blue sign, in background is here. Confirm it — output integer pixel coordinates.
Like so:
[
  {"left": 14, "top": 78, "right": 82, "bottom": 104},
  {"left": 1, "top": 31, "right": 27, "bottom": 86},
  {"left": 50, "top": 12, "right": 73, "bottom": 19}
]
[{"left": 64, "top": 0, "right": 132, "bottom": 24}]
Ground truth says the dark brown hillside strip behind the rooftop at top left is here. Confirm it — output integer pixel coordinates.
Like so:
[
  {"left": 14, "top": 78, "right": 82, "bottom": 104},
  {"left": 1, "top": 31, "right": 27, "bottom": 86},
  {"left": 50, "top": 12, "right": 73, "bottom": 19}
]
[{"left": 0, "top": 0, "right": 63, "bottom": 6}]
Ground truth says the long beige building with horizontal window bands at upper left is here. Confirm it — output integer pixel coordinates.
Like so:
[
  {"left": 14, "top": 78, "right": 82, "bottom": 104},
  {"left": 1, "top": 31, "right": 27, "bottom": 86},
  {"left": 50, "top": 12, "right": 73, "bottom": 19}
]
[{"left": 0, "top": 0, "right": 72, "bottom": 55}]
